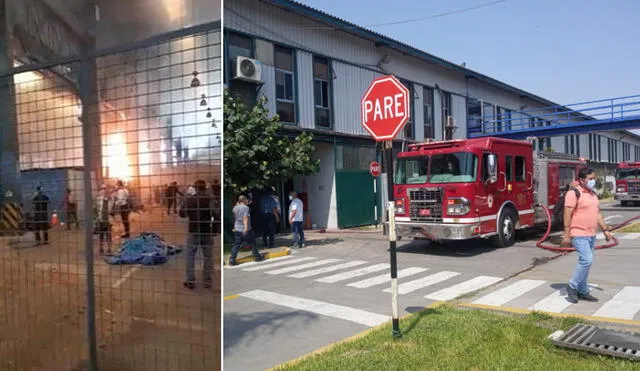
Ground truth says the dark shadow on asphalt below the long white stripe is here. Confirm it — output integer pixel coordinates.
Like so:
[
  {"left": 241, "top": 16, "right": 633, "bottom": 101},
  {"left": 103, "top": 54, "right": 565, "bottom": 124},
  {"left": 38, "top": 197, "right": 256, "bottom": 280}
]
[{"left": 224, "top": 311, "right": 318, "bottom": 349}]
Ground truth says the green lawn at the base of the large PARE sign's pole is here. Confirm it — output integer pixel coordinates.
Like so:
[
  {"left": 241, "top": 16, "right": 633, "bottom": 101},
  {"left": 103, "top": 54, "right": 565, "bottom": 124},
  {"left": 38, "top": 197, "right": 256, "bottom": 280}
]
[{"left": 277, "top": 306, "right": 640, "bottom": 371}]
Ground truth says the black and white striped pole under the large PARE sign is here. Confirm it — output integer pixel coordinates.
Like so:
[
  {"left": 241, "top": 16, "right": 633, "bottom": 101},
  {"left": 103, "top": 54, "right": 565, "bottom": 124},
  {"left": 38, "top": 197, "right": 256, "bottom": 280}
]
[{"left": 384, "top": 140, "right": 402, "bottom": 339}]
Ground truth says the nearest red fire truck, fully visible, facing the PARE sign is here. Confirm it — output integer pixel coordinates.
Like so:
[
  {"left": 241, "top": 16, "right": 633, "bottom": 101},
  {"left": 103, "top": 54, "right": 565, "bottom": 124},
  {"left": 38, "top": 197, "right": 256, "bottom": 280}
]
[{"left": 393, "top": 137, "right": 586, "bottom": 247}]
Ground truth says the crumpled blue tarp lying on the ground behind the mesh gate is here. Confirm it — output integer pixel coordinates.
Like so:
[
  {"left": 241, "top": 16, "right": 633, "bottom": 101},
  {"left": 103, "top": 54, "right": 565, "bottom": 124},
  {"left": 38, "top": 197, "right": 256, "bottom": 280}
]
[{"left": 105, "top": 232, "right": 182, "bottom": 265}]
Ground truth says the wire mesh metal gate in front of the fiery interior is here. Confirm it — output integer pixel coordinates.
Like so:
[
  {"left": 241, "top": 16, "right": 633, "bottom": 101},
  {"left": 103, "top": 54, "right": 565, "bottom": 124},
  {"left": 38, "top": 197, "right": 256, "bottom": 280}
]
[{"left": 0, "top": 3, "right": 222, "bottom": 370}]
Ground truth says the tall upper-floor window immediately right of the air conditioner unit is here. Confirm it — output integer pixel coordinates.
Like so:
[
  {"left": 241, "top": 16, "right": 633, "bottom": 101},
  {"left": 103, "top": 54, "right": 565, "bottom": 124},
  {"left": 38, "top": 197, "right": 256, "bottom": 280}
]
[{"left": 274, "top": 46, "right": 296, "bottom": 123}]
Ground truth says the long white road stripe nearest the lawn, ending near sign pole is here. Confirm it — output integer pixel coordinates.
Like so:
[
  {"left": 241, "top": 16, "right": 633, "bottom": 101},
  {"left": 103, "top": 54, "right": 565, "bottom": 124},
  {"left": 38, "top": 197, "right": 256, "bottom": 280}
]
[{"left": 239, "top": 290, "right": 391, "bottom": 327}]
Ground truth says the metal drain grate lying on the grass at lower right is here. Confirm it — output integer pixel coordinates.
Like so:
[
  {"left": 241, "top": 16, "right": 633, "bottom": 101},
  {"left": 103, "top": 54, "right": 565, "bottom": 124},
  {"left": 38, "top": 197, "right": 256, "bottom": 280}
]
[{"left": 550, "top": 324, "right": 640, "bottom": 361}]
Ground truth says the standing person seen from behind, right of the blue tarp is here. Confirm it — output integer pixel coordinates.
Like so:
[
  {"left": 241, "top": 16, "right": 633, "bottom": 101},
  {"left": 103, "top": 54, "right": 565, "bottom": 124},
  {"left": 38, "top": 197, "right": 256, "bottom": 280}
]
[{"left": 180, "top": 180, "right": 214, "bottom": 290}]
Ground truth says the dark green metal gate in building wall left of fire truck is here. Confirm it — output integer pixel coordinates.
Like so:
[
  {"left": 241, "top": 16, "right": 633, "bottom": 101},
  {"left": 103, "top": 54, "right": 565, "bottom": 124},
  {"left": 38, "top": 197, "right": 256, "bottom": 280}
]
[{"left": 336, "top": 145, "right": 378, "bottom": 228}]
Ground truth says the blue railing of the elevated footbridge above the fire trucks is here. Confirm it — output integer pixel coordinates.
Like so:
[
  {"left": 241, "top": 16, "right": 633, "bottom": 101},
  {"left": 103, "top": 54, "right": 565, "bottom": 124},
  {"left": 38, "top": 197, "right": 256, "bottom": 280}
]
[{"left": 468, "top": 95, "right": 640, "bottom": 137}]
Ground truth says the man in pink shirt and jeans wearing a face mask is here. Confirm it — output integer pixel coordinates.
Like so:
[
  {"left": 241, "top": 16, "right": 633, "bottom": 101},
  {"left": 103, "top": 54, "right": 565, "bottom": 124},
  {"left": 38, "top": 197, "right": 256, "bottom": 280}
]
[{"left": 562, "top": 168, "right": 611, "bottom": 304}]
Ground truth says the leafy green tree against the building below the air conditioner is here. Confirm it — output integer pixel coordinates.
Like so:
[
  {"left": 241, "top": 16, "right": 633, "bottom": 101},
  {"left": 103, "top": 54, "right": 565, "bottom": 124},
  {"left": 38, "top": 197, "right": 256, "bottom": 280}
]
[{"left": 224, "top": 91, "right": 320, "bottom": 193}]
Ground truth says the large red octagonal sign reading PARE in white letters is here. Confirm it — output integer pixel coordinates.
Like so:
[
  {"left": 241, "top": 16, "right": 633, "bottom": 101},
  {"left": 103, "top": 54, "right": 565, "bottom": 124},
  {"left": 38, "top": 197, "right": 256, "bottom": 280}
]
[{"left": 362, "top": 76, "right": 409, "bottom": 142}]
